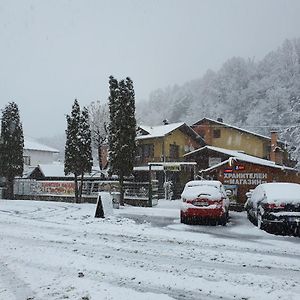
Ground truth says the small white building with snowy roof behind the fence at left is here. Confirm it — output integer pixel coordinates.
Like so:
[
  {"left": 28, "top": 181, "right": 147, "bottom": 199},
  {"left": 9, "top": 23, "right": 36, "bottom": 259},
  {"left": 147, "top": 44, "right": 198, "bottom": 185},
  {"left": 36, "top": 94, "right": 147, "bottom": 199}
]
[{"left": 23, "top": 137, "right": 59, "bottom": 166}]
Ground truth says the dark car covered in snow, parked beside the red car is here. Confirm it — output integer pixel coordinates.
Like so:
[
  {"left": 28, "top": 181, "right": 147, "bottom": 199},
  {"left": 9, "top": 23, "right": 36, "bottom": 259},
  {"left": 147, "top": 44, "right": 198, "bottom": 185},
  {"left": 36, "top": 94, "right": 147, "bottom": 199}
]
[{"left": 245, "top": 182, "right": 300, "bottom": 235}]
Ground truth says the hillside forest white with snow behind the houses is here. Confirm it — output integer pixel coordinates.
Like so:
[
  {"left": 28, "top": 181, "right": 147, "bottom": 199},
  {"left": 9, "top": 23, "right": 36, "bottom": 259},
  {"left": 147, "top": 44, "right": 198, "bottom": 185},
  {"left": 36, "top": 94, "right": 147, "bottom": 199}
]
[{"left": 137, "top": 39, "right": 300, "bottom": 166}]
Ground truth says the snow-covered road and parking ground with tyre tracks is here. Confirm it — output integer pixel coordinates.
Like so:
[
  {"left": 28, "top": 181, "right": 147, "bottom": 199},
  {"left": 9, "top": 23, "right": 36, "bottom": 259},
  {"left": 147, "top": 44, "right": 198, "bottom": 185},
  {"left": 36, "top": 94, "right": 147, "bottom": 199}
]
[{"left": 0, "top": 200, "right": 300, "bottom": 300}]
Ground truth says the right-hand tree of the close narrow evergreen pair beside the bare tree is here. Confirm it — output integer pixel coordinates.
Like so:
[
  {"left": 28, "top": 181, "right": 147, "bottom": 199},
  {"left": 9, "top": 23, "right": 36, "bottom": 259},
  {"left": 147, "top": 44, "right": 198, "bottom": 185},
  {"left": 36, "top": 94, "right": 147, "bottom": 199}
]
[{"left": 79, "top": 107, "right": 93, "bottom": 200}]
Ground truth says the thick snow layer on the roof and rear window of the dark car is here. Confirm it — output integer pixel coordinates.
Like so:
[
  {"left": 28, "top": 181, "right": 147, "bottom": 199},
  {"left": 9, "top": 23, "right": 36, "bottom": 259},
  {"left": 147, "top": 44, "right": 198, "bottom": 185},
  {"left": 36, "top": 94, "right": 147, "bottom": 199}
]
[{"left": 261, "top": 182, "right": 300, "bottom": 204}]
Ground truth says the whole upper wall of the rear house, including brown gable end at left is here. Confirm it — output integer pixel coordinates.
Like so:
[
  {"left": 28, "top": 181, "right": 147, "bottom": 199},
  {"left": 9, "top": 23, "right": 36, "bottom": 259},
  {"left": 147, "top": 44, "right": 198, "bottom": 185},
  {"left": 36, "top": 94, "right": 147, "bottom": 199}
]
[{"left": 193, "top": 123, "right": 270, "bottom": 159}]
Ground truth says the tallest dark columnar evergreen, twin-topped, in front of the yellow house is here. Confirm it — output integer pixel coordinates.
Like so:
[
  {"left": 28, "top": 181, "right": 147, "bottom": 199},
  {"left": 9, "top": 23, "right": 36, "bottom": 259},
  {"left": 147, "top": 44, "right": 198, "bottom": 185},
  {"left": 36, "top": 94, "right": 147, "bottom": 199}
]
[{"left": 109, "top": 76, "right": 136, "bottom": 205}]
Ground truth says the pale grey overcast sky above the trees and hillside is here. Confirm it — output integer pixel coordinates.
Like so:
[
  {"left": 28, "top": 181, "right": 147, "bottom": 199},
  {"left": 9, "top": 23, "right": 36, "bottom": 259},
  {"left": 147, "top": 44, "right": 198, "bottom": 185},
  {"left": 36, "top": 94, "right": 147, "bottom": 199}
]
[{"left": 0, "top": 0, "right": 300, "bottom": 137}]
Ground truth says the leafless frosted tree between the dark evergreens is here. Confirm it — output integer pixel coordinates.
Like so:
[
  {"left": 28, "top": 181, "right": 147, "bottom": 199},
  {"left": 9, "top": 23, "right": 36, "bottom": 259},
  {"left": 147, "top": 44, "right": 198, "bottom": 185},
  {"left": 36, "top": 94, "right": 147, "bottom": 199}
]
[{"left": 88, "top": 101, "right": 109, "bottom": 170}]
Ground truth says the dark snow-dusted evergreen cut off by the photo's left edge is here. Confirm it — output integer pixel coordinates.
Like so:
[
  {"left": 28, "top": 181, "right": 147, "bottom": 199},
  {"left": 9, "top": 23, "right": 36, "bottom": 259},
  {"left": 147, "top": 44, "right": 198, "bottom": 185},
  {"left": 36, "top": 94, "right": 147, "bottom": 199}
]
[{"left": 0, "top": 102, "right": 24, "bottom": 199}]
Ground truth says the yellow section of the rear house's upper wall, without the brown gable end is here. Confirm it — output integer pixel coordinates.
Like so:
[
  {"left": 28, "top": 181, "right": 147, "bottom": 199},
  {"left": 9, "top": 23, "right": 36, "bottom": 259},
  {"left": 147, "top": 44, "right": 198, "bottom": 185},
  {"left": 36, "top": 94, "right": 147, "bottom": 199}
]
[{"left": 211, "top": 125, "right": 268, "bottom": 158}]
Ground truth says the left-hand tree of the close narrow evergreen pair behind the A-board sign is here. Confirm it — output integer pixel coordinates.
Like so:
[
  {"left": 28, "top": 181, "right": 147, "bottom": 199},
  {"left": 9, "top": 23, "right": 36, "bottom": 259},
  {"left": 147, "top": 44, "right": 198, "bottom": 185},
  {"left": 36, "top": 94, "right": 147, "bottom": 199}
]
[{"left": 64, "top": 99, "right": 81, "bottom": 203}]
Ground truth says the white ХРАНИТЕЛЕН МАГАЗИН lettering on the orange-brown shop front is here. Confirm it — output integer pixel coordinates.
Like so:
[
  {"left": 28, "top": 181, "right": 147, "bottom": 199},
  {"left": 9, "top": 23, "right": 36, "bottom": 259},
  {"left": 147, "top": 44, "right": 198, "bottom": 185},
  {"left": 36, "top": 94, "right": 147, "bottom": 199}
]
[{"left": 224, "top": 171, "right": 268, "bottom": 185}]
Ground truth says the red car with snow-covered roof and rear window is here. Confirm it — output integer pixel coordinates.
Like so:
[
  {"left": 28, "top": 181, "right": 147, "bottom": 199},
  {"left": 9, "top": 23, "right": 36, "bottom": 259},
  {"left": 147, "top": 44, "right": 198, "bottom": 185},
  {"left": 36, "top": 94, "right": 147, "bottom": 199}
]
[{"left": 180, "top": 180, "right": 229, "bottom": 225}]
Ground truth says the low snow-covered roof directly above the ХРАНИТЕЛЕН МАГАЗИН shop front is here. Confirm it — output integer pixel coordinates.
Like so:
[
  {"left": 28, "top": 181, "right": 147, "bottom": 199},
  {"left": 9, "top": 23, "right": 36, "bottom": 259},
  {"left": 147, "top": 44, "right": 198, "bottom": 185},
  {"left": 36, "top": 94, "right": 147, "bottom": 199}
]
[{"left": 184, "top": 146, "right": 297, "bottom": 171}]
